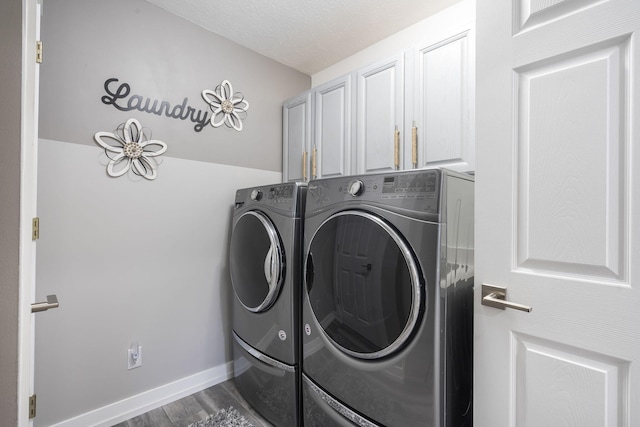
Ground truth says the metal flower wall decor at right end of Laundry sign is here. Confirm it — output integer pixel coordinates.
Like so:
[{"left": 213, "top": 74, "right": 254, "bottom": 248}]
[{"left": 202, "top": 80, "right": 249, "bottom": 132}]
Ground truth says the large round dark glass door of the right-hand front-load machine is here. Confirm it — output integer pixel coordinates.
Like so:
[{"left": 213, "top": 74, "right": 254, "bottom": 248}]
[{"left": 305, "top": 211, "right": 423, "bottom": 359}]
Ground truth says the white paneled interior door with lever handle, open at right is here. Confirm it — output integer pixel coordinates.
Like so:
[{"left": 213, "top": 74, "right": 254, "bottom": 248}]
[{"left": 474, "top": 0, "right": 640, "bottom": 427}]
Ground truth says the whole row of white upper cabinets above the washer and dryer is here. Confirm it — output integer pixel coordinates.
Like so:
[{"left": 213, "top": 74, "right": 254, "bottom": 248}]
[{"left": 283, "top": 2, "right": 475, "bottom": 181}]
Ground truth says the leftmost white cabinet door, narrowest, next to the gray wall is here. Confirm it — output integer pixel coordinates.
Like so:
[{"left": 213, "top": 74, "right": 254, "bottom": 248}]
[{"left": 282, "top": 91, "right": 312, "bottom": 181}]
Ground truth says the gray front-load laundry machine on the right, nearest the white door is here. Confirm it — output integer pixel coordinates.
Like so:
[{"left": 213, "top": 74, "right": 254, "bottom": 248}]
[{"left": 302, "top": 169, "right": 474, "bottom": 427}]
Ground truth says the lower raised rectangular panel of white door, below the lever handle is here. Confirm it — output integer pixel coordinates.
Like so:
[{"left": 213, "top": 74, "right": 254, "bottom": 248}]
[{"left": 512, "top": 333, "right": 629, "bottom": 427}]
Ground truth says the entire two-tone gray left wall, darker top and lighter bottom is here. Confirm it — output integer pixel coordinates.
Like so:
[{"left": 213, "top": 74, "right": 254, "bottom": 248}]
[{"left": 35, "top": 0, "right": 310, "bottom": 427}]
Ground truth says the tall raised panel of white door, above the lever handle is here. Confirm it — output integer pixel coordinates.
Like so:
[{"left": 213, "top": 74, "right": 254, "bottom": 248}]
[{"left": 514, "top": 37, "right": 630, "bottom": 281}]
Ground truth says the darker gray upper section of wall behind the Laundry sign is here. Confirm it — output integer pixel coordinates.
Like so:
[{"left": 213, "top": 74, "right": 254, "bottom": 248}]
[{"left": 40, "top": 0, "right": 311, "bottom": 171}]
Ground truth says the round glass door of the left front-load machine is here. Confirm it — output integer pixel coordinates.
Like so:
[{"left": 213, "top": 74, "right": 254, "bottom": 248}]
[{"left": 229, "top": 211, "right": 285, "bottom": 313}]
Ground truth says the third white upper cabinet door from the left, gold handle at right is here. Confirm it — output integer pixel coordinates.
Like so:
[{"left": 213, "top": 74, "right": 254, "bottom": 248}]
[{"left": 356, "top": 55, "right": 404, "bottom": 173}]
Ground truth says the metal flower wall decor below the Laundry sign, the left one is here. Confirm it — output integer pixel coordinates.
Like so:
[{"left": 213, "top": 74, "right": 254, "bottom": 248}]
[{"left": 94, "top": 119, "right": 167, "bottom": 180}]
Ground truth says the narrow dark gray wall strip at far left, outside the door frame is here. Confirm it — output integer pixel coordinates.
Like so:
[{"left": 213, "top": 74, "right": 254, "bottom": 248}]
[{"left": 0, "top": 0, "right": 22, "bottom": 427}]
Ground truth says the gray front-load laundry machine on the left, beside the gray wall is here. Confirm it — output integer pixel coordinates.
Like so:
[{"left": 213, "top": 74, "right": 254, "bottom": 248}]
[{"left": 229, "top": 183, "right": 306, "bottom": 427}]
